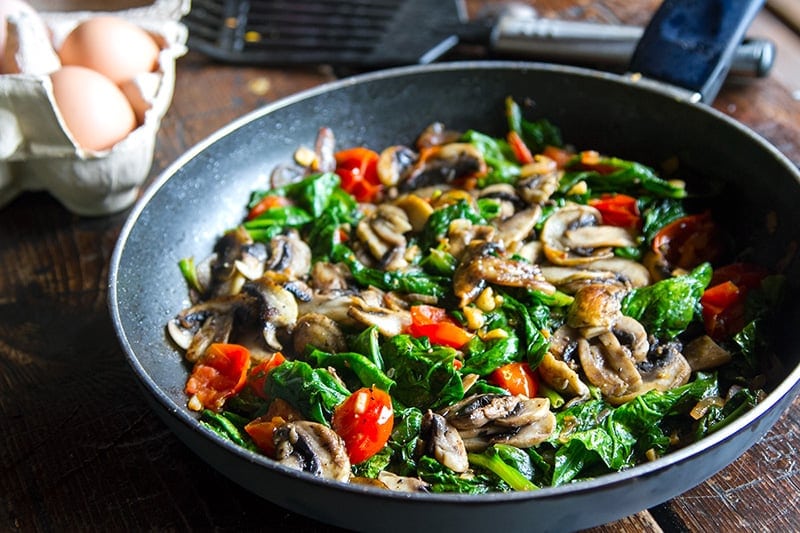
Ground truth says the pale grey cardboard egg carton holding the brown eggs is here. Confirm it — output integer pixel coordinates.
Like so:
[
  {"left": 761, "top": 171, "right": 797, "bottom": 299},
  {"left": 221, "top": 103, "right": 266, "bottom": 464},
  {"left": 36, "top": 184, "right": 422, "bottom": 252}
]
[{"left": 0, "top": 0, "right": 190, "bottom": 216}]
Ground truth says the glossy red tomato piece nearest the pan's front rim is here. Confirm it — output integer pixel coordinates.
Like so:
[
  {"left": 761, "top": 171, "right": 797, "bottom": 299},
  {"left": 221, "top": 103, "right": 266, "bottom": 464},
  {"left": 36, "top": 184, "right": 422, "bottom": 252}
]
[{"left": 331, "top": 387, "right": 394, "bottom": 464}]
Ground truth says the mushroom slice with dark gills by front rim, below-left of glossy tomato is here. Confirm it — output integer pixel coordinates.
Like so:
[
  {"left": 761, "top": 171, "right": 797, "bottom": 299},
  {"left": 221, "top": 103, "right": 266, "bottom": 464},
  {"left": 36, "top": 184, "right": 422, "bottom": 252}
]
[{"left": 273, "top": 420, "right": 350, "bottom": 482}]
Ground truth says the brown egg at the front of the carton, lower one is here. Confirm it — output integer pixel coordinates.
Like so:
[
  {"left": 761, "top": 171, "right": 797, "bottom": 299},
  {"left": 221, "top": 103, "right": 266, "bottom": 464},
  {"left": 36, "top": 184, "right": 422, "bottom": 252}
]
[{"left": 50, "top": 66, "right": 137, "bottom": 151}]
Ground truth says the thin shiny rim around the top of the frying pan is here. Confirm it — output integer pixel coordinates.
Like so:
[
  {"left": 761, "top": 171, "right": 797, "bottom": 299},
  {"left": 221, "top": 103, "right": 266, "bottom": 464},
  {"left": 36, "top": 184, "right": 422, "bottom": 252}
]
[{"left": 108, "top": 61, "right": 800, "bottom": 505}]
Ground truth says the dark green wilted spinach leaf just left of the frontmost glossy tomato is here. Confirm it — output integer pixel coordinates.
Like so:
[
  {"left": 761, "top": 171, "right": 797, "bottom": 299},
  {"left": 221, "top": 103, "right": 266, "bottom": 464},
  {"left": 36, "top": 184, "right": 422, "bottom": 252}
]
[{"left": 264, "top": 361, "right": 350, "bottom": 425}]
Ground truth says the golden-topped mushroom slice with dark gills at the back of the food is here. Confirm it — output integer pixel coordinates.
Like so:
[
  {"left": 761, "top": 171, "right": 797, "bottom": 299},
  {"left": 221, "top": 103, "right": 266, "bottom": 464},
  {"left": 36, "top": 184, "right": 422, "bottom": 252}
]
[{"left": 399, "top": 143, "right": 486, "bottom": 191}]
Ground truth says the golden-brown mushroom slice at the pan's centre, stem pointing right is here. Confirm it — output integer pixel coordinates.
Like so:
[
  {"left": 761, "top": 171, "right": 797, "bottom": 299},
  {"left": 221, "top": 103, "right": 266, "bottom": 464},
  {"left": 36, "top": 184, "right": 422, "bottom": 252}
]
[{"left": 453, "top": 241, "right": 555, "bottom": 307}]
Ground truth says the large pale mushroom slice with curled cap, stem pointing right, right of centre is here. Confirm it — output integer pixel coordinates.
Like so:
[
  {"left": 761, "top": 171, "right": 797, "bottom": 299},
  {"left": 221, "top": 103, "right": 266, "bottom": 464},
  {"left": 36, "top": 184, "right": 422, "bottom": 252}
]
[{"left": 540, "top": 205, "right": 636, "bottom": 266}]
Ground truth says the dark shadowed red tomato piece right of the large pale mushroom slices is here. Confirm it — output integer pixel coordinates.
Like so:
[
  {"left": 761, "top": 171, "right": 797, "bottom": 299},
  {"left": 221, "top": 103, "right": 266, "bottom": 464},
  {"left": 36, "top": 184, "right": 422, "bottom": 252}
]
[{"left": 652, "top": 212, "right": 725, "bottom": 270}]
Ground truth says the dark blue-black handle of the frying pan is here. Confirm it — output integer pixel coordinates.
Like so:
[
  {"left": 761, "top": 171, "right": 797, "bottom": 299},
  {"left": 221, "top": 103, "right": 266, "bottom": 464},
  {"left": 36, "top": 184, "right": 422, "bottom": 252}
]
[{"left": 629, "top": 0, "right": 764, "bottom": 102}]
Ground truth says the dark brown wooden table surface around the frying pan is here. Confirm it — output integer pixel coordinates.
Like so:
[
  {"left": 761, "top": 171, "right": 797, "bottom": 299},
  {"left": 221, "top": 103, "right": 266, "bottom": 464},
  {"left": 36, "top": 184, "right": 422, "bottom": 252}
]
[{"left": 0, "top": 0, "right": 800, "bottom": 532}]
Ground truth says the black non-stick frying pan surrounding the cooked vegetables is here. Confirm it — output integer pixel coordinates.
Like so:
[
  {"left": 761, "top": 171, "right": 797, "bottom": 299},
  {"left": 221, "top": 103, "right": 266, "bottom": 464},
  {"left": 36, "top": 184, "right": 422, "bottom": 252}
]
[{"left": 109, "top": 2, "right": 800, "bottom": 531}]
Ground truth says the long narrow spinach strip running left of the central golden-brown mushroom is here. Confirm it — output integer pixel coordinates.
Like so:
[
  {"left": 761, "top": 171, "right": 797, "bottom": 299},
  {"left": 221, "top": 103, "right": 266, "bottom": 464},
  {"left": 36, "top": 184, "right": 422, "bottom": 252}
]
[{"left": 332, "top": 244, "right": 449, "bottom": 298}]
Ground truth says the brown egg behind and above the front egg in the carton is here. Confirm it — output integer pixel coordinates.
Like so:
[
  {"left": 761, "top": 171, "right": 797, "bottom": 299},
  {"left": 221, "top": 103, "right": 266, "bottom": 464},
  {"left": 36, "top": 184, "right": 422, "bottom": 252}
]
[{"left": 58, "top": 15, "right": 159, "bottom": 84}]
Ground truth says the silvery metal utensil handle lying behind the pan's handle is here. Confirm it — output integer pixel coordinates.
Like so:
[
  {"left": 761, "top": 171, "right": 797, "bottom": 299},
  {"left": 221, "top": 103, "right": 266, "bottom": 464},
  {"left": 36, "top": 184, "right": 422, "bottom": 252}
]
[{"left": 491, "top": 14, "right": 775, "bottom": 77}]
